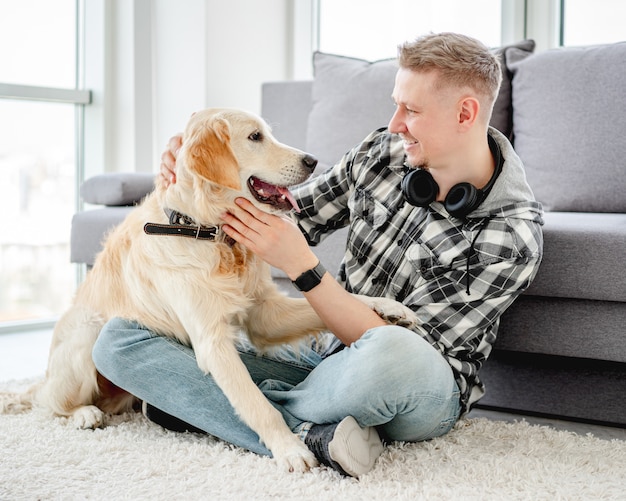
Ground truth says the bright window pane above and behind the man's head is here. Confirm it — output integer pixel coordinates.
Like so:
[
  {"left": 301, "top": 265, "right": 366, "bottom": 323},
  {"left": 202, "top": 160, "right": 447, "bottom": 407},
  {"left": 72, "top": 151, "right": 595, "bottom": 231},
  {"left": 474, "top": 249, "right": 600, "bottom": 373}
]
[{"left": 319, "top": 0, "right": 501, "bottom": 60}]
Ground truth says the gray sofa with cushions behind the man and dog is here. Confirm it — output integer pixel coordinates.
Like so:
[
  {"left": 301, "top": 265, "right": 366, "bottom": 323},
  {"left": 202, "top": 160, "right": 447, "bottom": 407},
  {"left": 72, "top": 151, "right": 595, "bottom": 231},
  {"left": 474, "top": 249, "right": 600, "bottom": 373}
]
[{"left": 71, "top": 41, "right": 626, "bottom": 427}]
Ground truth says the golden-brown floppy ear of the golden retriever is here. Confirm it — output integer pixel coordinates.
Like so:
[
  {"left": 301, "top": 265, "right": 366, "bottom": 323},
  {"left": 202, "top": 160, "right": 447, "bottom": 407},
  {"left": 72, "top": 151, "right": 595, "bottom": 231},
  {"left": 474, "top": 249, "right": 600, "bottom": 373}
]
[{"left": 186, "top": 117, "right": 241, "bottom": 190}]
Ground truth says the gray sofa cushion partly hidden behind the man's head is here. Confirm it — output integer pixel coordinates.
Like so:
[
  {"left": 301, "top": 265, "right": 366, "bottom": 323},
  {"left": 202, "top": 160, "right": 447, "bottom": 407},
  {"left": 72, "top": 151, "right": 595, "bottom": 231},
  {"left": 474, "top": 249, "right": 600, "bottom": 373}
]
[{"left": 305, "top": 40, "right": 535, "bottom": 167}]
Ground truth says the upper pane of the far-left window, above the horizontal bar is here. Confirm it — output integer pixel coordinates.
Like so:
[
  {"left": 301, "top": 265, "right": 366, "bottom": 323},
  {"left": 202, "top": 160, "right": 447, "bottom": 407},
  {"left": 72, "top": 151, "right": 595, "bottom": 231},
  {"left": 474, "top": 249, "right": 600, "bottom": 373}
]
[{"left": 0, "top": 0, "right": 76, "bottom": 89}]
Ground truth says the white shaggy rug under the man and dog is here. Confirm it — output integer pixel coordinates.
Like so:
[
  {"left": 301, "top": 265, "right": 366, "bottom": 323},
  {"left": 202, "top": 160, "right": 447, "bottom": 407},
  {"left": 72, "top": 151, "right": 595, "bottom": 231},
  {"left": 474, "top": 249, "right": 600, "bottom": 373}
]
[{"left": 0, "top": 381, "right": 626, "bottom": 501}]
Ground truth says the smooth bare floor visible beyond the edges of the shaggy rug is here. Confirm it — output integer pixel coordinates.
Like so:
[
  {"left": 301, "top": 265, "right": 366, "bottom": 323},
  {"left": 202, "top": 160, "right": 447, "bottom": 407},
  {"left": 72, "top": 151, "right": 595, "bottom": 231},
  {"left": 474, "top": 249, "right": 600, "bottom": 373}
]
[{"left": 0, "top": 330, "right": 626, "bottom": 440}]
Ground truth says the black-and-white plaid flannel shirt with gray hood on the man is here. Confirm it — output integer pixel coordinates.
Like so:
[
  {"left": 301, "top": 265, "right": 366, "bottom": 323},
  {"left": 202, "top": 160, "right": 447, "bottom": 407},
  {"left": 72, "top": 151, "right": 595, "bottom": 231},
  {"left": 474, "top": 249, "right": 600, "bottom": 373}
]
[{"left": 294, "top": 129, "right": 543, "bottom": 412}]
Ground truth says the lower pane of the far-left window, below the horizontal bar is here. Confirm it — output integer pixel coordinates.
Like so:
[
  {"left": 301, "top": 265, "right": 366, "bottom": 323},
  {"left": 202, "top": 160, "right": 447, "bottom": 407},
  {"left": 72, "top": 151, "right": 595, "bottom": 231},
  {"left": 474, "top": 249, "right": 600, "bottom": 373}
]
[{"left": 0, "top": 99, "right": 76, "bottom": 322}]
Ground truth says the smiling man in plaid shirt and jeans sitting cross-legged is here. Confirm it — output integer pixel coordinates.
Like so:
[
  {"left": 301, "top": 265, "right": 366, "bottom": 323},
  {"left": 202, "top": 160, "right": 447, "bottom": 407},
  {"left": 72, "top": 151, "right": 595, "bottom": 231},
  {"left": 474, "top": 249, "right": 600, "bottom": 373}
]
[{"left": 94, "top": 33, "right": 542, "bottom": 477}]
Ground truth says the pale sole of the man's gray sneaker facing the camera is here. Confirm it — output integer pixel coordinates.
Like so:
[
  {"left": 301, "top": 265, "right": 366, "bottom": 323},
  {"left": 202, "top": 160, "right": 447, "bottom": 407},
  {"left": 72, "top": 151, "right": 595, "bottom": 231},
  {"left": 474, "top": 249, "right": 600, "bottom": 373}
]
[{"left": 328, "top": 416, "right": 384, "bottom": 477}]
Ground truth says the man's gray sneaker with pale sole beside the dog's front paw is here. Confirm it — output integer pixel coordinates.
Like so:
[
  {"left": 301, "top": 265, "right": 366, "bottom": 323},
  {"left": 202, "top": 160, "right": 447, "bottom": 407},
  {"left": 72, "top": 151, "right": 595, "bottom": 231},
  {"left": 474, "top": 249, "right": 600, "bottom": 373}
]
[{"left": 304, "top": 416, "right": 384, "bottom": 477}]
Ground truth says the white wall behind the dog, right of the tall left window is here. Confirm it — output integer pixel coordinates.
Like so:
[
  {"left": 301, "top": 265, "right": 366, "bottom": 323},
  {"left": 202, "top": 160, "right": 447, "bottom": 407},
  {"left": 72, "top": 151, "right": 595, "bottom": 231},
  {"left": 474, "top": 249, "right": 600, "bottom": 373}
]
[{"left": 85, "top": 0, "right": 313, "bottom": 177}]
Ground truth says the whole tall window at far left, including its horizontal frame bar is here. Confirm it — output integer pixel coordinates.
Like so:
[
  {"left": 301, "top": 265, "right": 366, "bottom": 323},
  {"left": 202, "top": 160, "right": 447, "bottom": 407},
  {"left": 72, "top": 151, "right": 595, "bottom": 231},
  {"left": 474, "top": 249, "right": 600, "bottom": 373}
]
[{"left": 0, "top": 0, "right": 84, "bottom": 330}]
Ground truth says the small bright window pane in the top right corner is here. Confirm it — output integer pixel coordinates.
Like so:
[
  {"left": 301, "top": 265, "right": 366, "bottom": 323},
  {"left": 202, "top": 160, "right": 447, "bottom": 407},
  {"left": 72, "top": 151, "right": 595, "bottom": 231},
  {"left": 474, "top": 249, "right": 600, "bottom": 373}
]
[{"left": 563, "top": 0, "right": 626, "bottom": 45}]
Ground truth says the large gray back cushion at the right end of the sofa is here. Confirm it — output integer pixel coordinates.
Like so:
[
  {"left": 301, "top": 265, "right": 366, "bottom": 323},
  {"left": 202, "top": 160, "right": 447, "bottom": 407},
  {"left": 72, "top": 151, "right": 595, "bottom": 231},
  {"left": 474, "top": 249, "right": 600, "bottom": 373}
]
[{"left": 513, "top": 43, "right": 626, "bottom": 212}]
